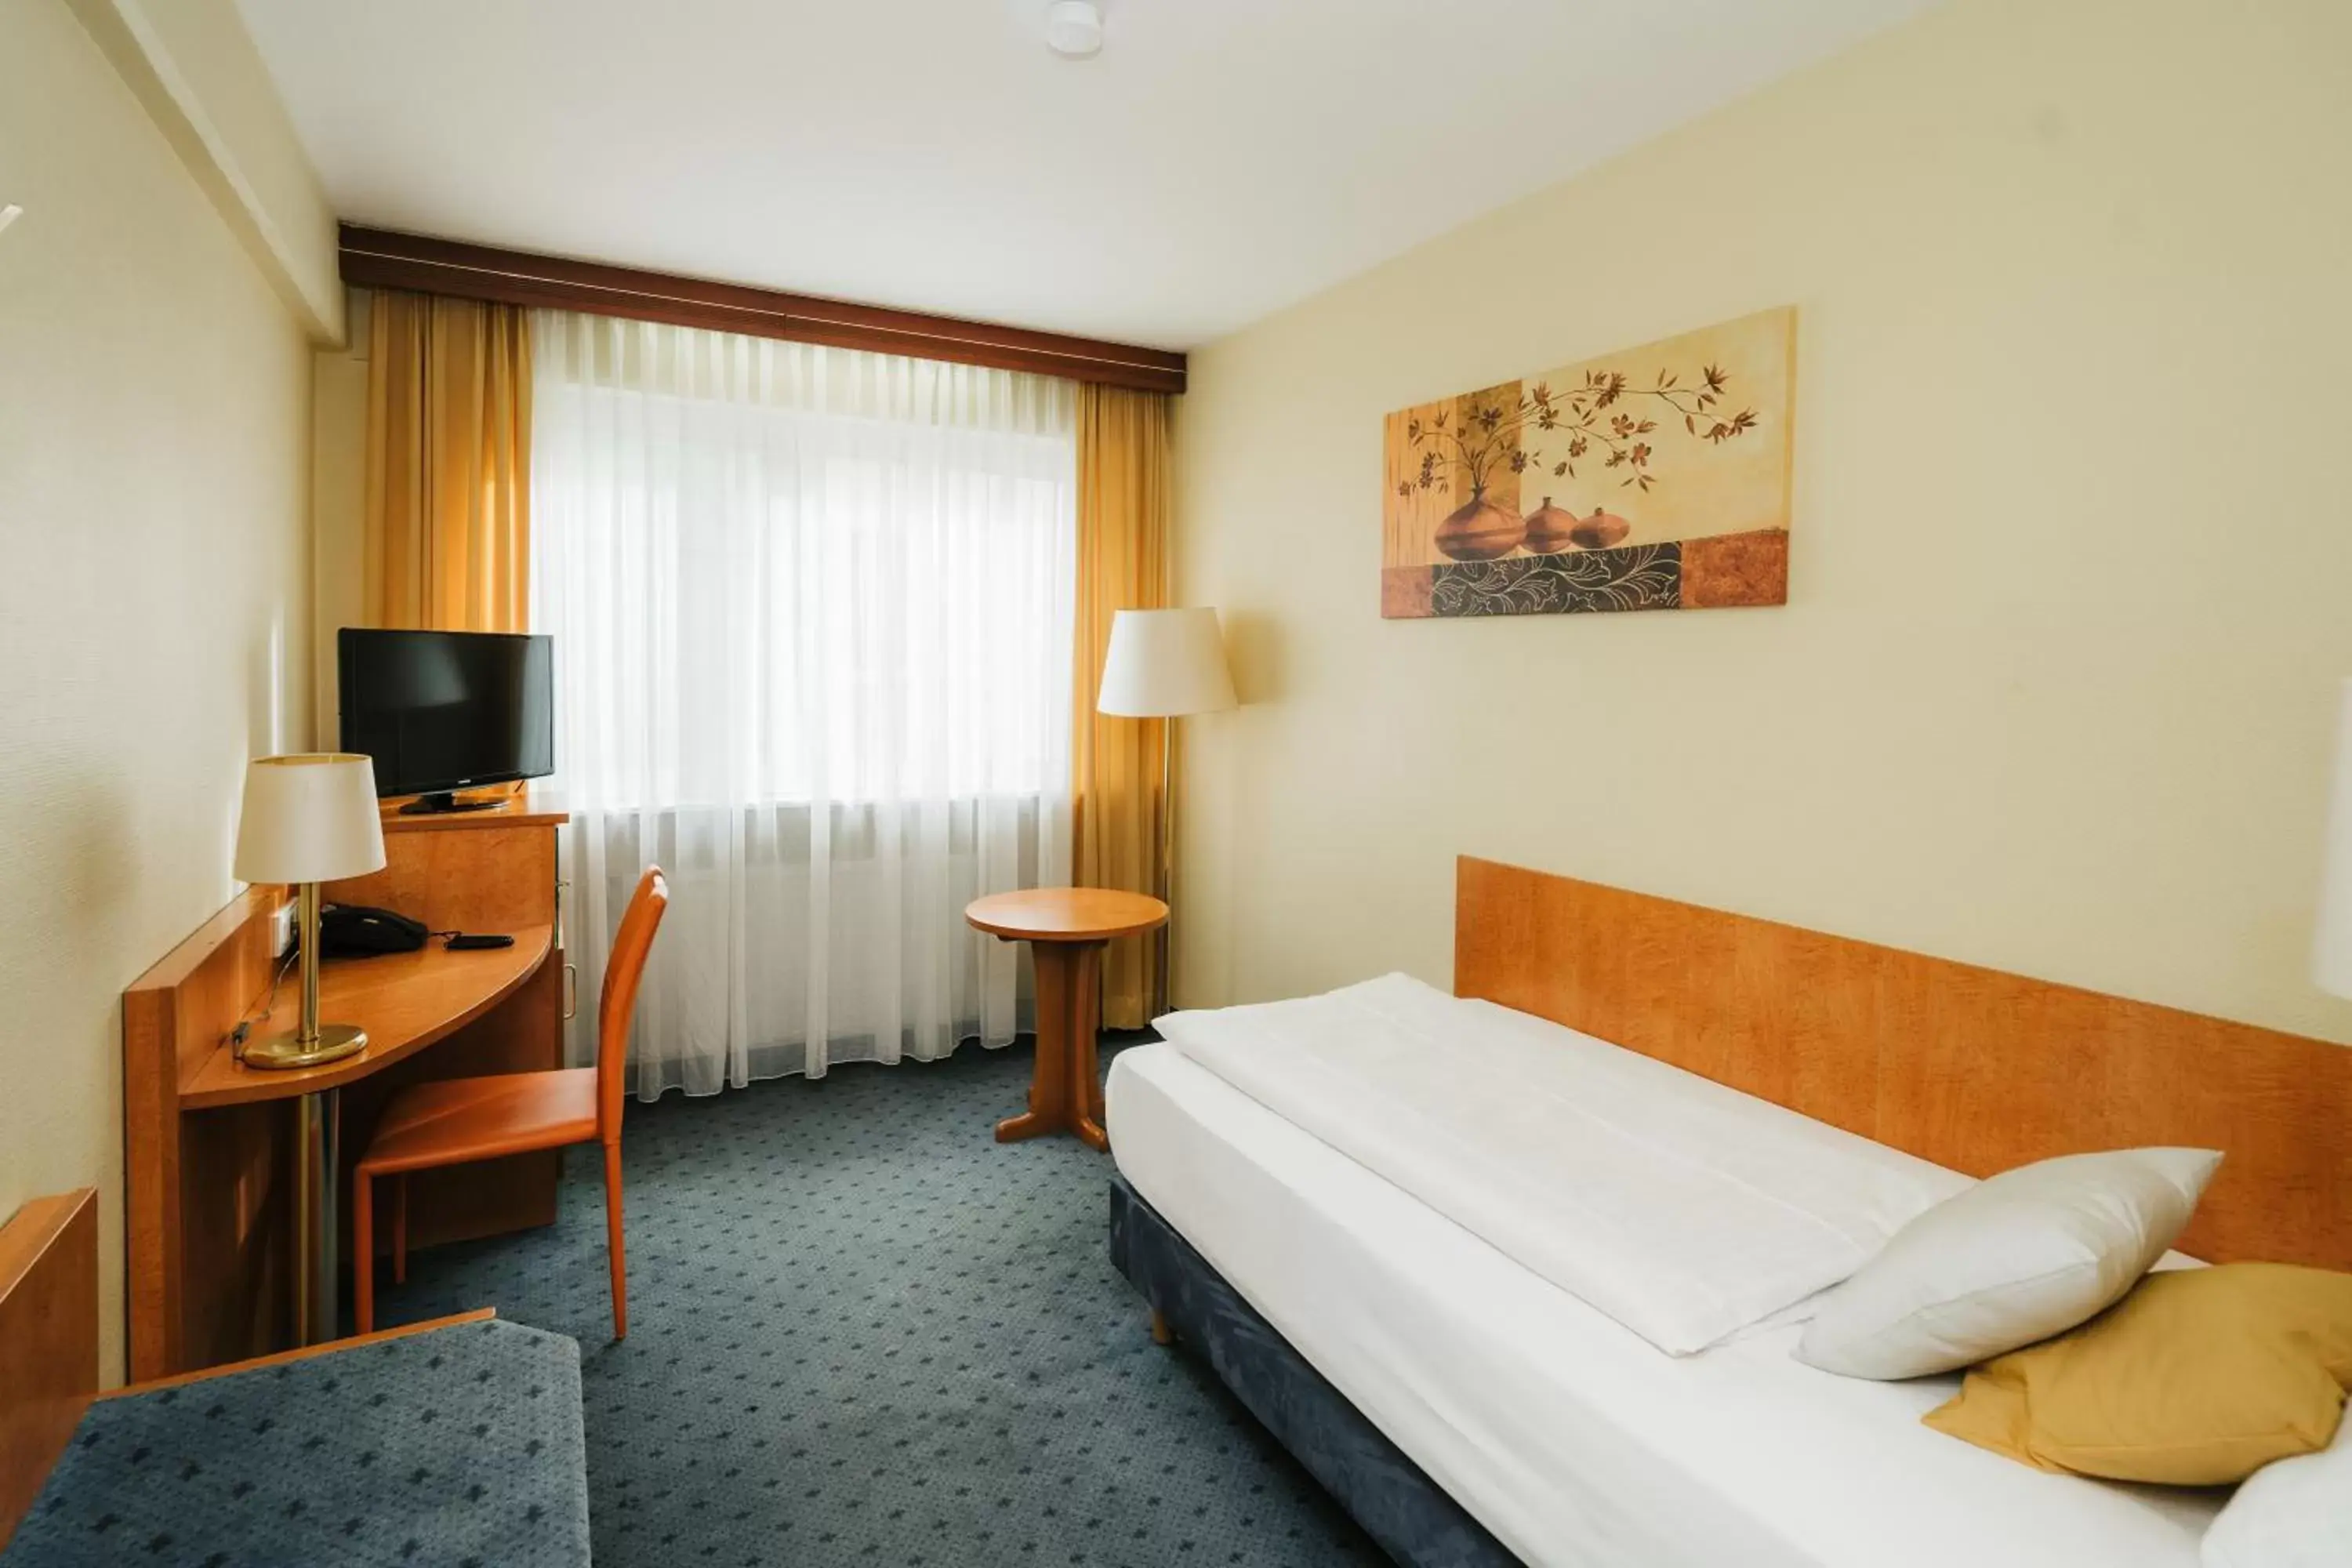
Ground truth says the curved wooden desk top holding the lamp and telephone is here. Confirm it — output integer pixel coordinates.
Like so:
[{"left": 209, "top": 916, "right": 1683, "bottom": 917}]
[{"left": 179, "top": 926, "right": 555, "bottom": 1109}]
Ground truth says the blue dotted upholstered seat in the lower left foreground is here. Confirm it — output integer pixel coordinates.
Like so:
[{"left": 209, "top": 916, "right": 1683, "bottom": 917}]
[{"left": 0, "top": 1319, "right": 588, "bottom": 1568}]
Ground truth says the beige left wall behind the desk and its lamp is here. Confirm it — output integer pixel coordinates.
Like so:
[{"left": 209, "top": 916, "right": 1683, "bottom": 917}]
[{"left": 0, "top": 0, "right": 310, "bottom": 1377}]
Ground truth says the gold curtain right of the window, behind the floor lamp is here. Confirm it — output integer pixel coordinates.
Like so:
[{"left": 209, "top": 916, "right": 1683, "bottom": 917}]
[{"left": 1070, "top": 386, "right": 1174, "bottom": 1029}]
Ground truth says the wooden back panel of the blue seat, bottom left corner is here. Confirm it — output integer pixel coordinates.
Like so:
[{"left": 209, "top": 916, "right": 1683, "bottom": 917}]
[{"left": 0, "top": 1187, "right": 99, "bottom": 1547}]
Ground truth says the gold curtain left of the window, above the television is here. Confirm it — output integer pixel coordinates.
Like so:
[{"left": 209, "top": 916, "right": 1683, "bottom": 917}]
[{"left": 362, "top": 292, "right": 532, "bottom": 633}]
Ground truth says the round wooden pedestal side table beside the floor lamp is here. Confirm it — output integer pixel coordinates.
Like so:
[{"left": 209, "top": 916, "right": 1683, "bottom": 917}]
[{"left": 964, "top": 888, "right": 1169, "bottom": 1149}]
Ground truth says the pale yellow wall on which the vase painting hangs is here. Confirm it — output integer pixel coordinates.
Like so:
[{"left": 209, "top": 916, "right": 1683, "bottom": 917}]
[{"left": 1178, "top": 0, "right": 2352, "bottom": 1039}]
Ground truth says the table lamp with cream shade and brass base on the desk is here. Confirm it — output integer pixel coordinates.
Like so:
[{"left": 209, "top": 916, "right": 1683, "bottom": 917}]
[{"left": 233, "top": 753, "right": 383, "bottom": 1067}]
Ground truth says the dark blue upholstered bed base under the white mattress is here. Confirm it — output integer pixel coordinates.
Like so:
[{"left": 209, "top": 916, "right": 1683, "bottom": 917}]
[{"left": 1110, "top": 1175, "right": 1519, "bottom": 1568}]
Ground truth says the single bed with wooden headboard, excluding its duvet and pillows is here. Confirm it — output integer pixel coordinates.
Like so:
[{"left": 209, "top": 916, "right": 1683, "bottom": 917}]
[{"left": 1108, "top": 860, "right": 2352, "bottom": 1568}]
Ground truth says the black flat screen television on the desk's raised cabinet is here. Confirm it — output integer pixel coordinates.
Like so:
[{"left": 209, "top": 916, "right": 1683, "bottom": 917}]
[{"left": 334, "top": 626, "right": 555, "bottom": 811}]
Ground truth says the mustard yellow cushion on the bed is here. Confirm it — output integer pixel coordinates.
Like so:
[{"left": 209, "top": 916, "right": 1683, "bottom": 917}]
[{"left": 1924, "top": 1262, "right": 2352, "bottom": 1486}]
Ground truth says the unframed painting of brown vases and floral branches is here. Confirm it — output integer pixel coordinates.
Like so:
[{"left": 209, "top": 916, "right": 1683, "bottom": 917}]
[{"left": 1381, "top": 310, "right": 1797, "bottom": 619}]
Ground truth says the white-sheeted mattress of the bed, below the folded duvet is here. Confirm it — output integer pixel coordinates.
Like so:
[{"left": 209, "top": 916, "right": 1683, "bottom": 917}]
[{"left": 1108, "top": 1044, "right": 2220, "bottom": 1568}]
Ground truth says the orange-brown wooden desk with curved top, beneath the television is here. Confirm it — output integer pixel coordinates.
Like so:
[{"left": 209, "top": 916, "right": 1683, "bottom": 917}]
[{"left": 122, "top": 794, "right": 567, "bottom": 1380}]
